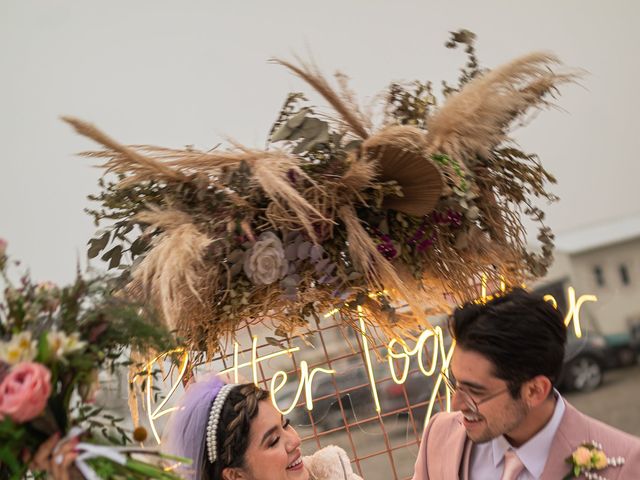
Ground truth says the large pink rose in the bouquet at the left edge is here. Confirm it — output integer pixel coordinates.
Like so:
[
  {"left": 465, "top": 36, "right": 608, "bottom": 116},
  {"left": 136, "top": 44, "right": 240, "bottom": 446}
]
[{"left": 0, "top": 362, "right": 51, "bottom": 423}]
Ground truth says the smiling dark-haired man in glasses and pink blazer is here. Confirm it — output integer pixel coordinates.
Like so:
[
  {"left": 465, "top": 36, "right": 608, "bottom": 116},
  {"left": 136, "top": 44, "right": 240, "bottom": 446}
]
[{"left": 413, "top": 290, "right": 640, "bottom": 480}]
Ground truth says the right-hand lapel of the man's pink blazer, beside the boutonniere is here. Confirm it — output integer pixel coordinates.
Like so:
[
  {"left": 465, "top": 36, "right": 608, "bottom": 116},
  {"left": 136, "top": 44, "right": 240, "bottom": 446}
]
[{"left": 540, "top": 400, "right": 589, "bottom": 480}]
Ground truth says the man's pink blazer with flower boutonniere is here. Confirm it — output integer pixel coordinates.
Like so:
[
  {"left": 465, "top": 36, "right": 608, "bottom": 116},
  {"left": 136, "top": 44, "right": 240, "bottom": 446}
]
[{"left": 413, "top": 401, "right": 640, "bottom": 480}]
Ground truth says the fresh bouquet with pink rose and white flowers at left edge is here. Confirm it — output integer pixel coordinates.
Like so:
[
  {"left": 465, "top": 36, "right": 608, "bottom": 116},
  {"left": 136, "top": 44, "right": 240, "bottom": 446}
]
[{"left": 0, "top": 239, "right": 188, "bottom": 480}]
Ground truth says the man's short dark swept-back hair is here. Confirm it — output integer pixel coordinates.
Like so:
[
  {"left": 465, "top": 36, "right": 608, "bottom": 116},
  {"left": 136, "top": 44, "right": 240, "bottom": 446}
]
[{"left": 449, "top": 289, "right": 567, "bottom": 398}]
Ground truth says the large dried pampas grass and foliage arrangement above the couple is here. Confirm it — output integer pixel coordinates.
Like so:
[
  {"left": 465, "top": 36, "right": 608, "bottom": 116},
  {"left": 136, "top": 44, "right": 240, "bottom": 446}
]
[{"left": 65, "top": 31, "right": 576, "bottom": 352}]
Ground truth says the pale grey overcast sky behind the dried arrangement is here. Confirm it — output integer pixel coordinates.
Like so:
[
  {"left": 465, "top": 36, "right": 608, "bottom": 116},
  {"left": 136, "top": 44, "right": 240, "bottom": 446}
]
[{"left": 0, "top": 0, "right": 640, "bottom": 282}]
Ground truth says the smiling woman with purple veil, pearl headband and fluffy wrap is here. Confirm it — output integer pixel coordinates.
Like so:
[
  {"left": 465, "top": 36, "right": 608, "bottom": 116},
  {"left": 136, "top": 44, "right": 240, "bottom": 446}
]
[{"left": 163, "top": 377, "right": 362, "bottom": 480}]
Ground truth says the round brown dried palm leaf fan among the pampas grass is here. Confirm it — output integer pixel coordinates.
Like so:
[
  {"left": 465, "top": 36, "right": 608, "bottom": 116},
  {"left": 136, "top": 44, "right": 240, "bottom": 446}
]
[{"left": 362, "top": 125, "right": 444, "bottom": 217}]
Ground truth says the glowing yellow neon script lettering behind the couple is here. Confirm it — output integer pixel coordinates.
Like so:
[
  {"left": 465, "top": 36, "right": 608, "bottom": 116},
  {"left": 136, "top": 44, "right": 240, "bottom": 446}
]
[{"left": 145, "top": 285, "right": 597, "bottom": 444}]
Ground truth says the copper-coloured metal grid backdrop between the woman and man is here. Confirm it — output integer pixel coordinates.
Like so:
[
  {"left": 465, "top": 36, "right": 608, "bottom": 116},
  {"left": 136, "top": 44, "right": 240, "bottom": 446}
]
[{"left": 153, "top": 316, "right": 446, "bottom": 480}]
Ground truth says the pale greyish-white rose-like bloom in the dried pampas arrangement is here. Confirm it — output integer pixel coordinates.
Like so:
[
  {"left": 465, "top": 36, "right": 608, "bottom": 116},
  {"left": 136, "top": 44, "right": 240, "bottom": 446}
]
[{"left": 244, "top": 232, "right": 288, "bottom": 285}]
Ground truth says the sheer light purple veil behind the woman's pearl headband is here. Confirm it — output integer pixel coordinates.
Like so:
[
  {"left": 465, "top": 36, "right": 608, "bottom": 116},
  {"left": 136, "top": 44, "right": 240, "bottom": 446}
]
[{"left": 162, "top": 375, "right": 225, "bottom": 480}]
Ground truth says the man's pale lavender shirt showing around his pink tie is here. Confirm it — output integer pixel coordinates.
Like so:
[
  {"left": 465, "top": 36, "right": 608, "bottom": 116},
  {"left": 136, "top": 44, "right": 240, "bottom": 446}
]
[{"left": 491, "top": 390, "right": 565, "bottom": 478}]
